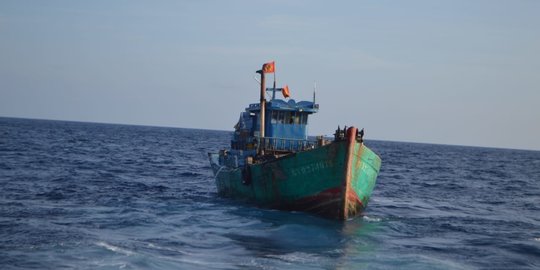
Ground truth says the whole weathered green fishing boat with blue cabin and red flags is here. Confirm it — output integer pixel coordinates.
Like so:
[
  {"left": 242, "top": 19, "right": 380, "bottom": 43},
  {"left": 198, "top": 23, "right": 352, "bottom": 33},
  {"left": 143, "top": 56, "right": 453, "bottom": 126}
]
[{"left": 208, "top": 62, "right": 381, "bottom": 220}]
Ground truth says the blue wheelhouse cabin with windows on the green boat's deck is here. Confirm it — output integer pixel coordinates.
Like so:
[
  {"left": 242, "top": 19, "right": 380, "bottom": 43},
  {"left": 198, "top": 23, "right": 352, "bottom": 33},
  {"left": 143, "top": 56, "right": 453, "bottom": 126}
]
[{"left": 231, "top": 88, "right": 319, "bottom": 152}]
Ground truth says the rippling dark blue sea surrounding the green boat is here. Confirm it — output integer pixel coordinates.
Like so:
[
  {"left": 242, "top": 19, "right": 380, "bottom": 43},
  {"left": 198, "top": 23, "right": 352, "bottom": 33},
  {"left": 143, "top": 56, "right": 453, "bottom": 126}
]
[{"left": 0, "top": 118, "right": 540, "bottom": 269}]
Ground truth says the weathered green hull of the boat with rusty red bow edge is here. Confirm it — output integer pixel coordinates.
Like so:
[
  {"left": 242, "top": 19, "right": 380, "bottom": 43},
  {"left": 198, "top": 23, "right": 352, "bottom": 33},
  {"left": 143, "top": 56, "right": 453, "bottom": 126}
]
[{"left": 210, "top": 134, "right": 381, "bottom": 220}]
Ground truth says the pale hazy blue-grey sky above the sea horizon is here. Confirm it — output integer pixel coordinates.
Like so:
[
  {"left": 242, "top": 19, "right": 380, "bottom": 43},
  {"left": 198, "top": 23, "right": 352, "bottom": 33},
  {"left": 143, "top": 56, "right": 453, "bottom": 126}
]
[{"left": 0, "top": 0, "right": 540, "bottom": 150}]
